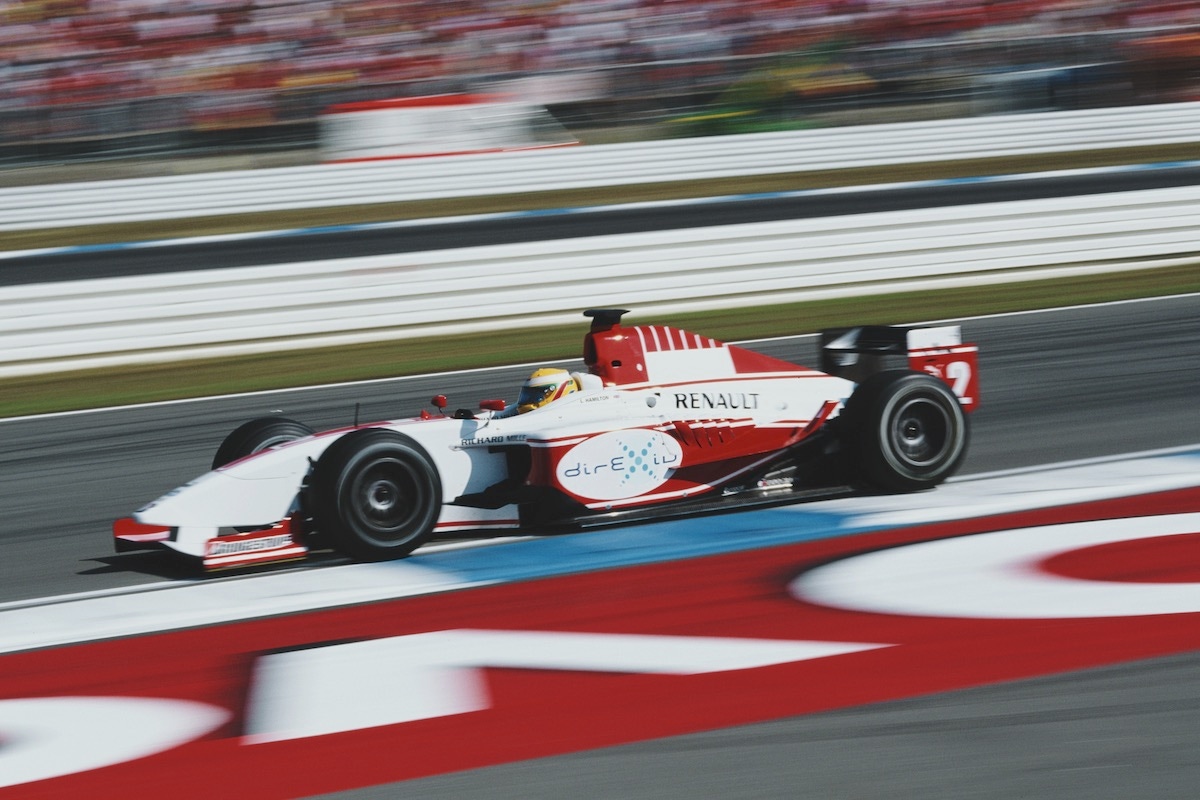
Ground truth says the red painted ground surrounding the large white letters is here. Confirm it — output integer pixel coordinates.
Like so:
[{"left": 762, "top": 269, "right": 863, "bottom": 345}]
[{"left": 0, "top": 489, "right": 1200, "bottom": 800}]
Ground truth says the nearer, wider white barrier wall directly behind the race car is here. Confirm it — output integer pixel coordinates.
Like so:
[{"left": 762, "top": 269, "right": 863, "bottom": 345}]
[{"left": 0, "top": 187, "right": 1200, "bottom": 377}]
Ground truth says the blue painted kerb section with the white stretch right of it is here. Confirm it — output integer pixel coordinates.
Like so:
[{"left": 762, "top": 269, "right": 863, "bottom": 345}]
[{"left": 407, "top": 445, "right": 1200, "bottom": 583}]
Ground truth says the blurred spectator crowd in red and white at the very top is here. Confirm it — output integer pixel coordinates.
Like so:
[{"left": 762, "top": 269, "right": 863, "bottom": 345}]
[{"left": 0, "top": 0, "right": 1200, "bottom": 110}]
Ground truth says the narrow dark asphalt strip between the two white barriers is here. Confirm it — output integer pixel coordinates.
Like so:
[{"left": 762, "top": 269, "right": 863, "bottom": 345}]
[{"left": 7, "top": 164, "right": 1200, "bottom": 285}]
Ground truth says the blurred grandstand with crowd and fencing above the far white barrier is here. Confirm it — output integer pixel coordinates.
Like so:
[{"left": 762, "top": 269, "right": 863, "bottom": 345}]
[{"left": 0, "top": 0, "right": 1200, "bottom": 166}]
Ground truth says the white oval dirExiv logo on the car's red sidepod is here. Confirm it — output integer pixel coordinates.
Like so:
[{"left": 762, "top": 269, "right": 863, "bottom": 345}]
[{"left": 557, "top": 429, "right": 683, "bottom": 500}]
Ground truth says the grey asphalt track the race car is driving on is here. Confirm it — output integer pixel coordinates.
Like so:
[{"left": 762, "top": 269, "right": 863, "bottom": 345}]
[{"left": 0, "top": 295, "right": 1200, "bottom": 602}]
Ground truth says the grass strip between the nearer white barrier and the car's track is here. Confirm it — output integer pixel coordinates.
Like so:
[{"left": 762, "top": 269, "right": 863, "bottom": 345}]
[{"left": 0, "top": 263, "right": 1200, "bottom": 417}]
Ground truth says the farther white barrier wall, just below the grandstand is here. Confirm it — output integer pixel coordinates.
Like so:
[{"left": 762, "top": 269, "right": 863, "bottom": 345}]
[{"left": 0, "top": 103, "right": 1200, "bottom": 231}]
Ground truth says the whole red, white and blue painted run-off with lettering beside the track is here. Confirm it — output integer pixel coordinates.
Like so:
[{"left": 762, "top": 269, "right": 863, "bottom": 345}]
[{"left": 0, "top": 450, "right": 1200, "bottom": 798}]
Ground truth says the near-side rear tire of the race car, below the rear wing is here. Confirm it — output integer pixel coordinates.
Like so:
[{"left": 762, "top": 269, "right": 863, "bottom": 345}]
[{"left": 844, "top": 369, "right": 968, "bottom": 492}]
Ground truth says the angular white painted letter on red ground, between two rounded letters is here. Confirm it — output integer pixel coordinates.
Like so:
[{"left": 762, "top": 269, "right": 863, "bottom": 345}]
[{"left": 246, "top": 628, "right": 888, "bottom": 744}]
